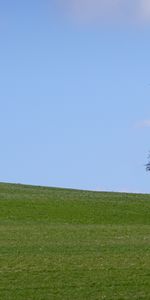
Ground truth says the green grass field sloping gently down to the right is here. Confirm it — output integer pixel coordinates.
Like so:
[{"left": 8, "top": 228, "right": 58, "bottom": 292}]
[{"left": 0, "top": 183, "right": 150, "bottom": 300}]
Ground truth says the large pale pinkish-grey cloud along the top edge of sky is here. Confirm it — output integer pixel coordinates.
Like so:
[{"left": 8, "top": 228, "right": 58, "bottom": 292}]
[{"left": 57, "top": 0, "right": 150, "bottom": 23}]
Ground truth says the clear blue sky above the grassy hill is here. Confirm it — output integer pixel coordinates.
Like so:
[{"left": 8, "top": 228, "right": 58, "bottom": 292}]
[{"left": 0, "top": 0, "right": 150, "bottom": 193}]
